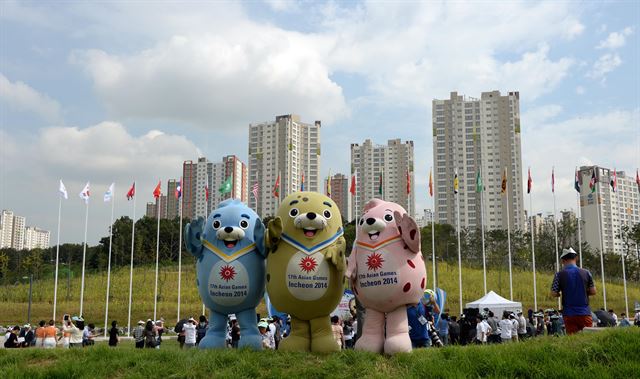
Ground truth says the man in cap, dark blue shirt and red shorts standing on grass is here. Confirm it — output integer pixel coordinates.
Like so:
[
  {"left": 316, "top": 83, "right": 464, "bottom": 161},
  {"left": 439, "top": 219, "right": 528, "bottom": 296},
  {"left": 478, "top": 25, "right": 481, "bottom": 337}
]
[{"left": 551, "top": 248, "right": 596, "bottom": 334}]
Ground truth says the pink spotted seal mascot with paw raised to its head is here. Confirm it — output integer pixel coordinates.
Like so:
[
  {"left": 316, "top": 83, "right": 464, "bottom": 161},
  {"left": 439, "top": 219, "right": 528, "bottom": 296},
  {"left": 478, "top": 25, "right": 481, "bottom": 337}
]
[{"left": 345, "top": 199, "right": 427, "bottom": 354}]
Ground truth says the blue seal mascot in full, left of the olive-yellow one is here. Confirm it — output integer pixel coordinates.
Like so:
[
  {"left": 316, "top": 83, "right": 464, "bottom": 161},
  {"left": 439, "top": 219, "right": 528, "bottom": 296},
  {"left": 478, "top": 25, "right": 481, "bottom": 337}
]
[{"left": 185, "top": 200, "right": 266, "bottom": 349}]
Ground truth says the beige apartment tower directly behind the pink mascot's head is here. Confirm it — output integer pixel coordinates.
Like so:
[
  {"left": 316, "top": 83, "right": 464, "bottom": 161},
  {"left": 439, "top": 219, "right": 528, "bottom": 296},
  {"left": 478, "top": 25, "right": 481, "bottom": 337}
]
[{"left": 351, "top": 138, "right": 415, "bottom": 218}]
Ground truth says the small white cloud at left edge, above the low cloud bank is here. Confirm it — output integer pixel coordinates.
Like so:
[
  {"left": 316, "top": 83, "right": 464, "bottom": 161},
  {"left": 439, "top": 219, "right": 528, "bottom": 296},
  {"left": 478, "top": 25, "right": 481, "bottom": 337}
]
[{"left": 0, "top": 73, "right": 62, "bottom": 123}]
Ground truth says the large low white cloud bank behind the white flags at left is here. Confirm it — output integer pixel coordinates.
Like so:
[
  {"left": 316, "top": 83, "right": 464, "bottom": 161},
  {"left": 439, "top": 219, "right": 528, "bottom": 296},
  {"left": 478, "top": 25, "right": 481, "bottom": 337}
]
[{"left": 0, "top": 122, "right": 197, "bottom": 243}]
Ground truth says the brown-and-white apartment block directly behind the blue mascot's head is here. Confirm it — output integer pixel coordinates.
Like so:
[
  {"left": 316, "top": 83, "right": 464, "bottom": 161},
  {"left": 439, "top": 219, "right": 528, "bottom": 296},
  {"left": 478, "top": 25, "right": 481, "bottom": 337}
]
[{"left": 182, "top": 155, "right": 248, "bottom": 219}]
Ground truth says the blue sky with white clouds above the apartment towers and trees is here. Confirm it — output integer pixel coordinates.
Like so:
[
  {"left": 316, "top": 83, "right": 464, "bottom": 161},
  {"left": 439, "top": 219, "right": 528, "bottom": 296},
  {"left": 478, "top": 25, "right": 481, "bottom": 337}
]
[{"left": 0, "top": 1, "right": 640, "bottom": 243}]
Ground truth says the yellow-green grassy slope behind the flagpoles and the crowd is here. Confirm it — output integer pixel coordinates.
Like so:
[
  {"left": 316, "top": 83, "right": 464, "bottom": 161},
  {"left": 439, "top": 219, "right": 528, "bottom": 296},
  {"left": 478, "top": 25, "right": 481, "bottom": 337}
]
[{"left": 0, "top": 261, "right": 640, "bottom": 326}]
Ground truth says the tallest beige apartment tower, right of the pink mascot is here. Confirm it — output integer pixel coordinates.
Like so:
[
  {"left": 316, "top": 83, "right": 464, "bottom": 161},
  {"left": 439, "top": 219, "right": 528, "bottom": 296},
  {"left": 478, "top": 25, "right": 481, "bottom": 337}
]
[{"left": 432, "top": 91, "right": 525, "bottom": 230}]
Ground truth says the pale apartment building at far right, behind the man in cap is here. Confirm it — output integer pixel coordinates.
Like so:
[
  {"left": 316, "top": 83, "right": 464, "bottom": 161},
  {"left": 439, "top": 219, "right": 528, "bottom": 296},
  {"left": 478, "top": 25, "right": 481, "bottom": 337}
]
[{"left": 578, "top": 166, "right": 640, "bottom": 254}]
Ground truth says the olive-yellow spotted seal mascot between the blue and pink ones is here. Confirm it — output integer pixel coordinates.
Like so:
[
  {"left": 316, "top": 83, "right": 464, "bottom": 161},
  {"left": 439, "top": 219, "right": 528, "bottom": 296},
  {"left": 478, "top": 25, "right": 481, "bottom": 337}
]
[{"left": 265, "top": 192, "right": 346, "bottom": 352}]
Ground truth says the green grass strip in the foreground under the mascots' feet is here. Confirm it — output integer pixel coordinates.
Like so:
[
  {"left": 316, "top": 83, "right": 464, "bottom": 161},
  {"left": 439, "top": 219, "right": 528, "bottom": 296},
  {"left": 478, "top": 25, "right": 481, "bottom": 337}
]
[{"left": 0, "top": 327, "right": 640, "bottom": 379}]
